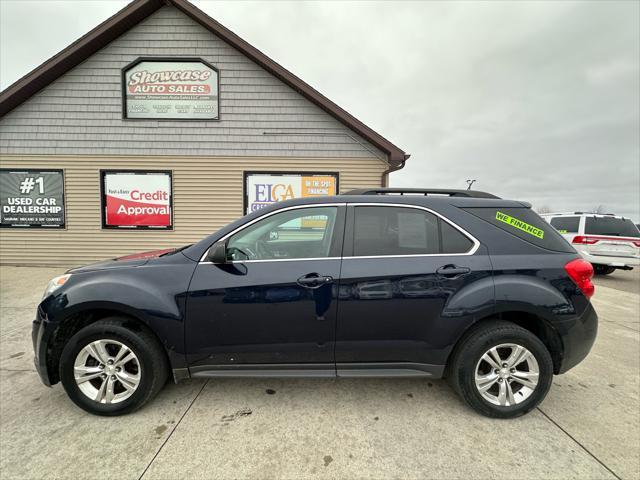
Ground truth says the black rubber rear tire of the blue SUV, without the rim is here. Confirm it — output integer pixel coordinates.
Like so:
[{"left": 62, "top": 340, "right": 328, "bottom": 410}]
[{"left": 447, "top": 320, "right": 553, "bottom": 418}]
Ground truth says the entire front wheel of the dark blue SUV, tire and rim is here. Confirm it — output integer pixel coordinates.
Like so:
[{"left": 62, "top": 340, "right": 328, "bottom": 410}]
[{"left": 60, "top": 318, "right": 168, "bottom": 415}]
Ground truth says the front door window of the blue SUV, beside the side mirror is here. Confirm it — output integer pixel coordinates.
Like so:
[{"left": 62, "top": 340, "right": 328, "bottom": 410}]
[{"left": 227, "top": 207, "right": 338, "bottom": 260}]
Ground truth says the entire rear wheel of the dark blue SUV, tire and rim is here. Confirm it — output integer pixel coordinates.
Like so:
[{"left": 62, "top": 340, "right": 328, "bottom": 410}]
[{"left": 448, "top": 321, "right": 553, "bottom": 418}]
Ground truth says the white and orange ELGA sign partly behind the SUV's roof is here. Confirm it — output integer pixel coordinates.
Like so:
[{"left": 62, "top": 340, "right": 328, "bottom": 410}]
[{"left": 244, "top": 172, "right": 338, "bottom": 213}]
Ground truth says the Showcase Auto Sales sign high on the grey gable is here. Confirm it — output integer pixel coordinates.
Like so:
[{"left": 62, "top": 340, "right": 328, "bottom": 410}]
[{"left": 122, "top": 59, "right": 219, "bottom": 120}]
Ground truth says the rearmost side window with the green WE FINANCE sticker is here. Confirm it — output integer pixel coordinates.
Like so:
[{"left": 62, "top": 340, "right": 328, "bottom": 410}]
[{"left": 464, "top": 207, "right": 574, "bottom": 253}]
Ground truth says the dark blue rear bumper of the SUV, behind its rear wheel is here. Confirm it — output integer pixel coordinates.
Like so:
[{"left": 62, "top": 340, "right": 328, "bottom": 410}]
[{"left": 554, "top": 302, "right": 598, "bottom": 373}]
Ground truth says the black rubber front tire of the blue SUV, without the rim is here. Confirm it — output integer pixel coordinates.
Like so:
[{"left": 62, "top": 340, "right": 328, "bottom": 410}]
[{"left": 60, "top": 317, "right": 169, "bottom": 416}]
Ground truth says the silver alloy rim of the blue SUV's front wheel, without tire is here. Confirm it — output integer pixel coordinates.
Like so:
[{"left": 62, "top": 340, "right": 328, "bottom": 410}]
[{"left": 73, "top": 339, "right": 142, "bottom": 404}]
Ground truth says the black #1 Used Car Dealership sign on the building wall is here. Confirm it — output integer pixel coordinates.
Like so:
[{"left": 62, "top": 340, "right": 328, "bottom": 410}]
[{"left": 0, "top": 169, "right": 64, "bottom": 228}]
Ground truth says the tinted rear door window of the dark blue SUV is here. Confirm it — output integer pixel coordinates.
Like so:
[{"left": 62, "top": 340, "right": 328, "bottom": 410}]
[{"left": 353, "top": 206, "right": 473, "bottom": 257}]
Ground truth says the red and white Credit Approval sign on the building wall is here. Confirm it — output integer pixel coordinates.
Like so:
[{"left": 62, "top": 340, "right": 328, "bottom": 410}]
[{"left": 101, "top": 170, "right": 172, "bottom": 229}]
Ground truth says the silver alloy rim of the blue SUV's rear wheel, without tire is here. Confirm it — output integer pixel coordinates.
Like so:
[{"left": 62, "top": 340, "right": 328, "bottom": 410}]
[{"left": 475, "top": 343, "right": 540, "bottom": 407}]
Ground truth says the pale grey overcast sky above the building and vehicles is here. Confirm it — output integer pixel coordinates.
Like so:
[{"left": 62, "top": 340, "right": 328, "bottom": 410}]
[{"left": 0, "top": 0, "right": 640, "bottom": 221}]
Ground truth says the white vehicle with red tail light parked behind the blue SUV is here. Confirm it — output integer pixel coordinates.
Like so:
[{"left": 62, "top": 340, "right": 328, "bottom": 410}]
[{"left": 541, "top": 212, "right": 640, "bottom": 275}]
